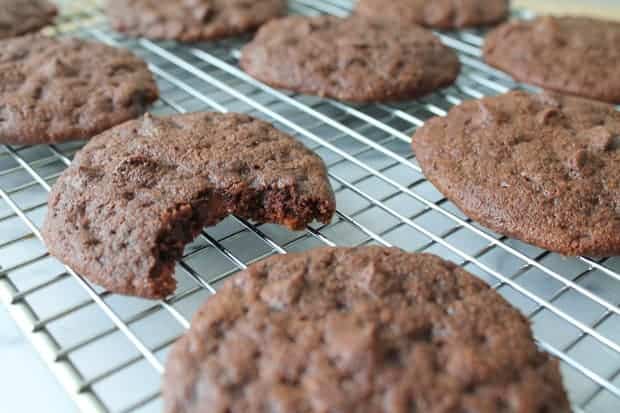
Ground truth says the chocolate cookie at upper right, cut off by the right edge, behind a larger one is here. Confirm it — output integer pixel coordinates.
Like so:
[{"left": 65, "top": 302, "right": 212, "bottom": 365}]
[{"left": 484, "top": 16, "right": 620, "bottom": 103}]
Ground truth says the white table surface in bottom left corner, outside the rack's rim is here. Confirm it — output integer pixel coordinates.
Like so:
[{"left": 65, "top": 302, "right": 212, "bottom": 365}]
[{"left": 0, "top": 304, "right": 78, "bottom": 413}]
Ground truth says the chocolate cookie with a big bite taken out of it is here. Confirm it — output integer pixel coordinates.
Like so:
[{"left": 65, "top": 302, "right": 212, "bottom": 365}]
[{"left": 43, "top": 113, "right": 335, "bottom": 298}]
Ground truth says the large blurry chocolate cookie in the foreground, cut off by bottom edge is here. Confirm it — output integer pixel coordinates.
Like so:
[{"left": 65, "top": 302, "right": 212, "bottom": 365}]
[{"left": 163, "top": 247, "right": 570, "bottom": 413}]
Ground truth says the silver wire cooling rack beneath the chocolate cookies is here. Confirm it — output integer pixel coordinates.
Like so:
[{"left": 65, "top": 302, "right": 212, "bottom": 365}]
[{"left": 0, "top": 0, "right": 620, "bottom": 412}]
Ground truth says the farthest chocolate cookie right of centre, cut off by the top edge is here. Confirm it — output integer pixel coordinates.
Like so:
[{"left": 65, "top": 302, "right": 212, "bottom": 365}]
[{"left": 356, "top": 0, "right": 510, "bottom": 29}]
